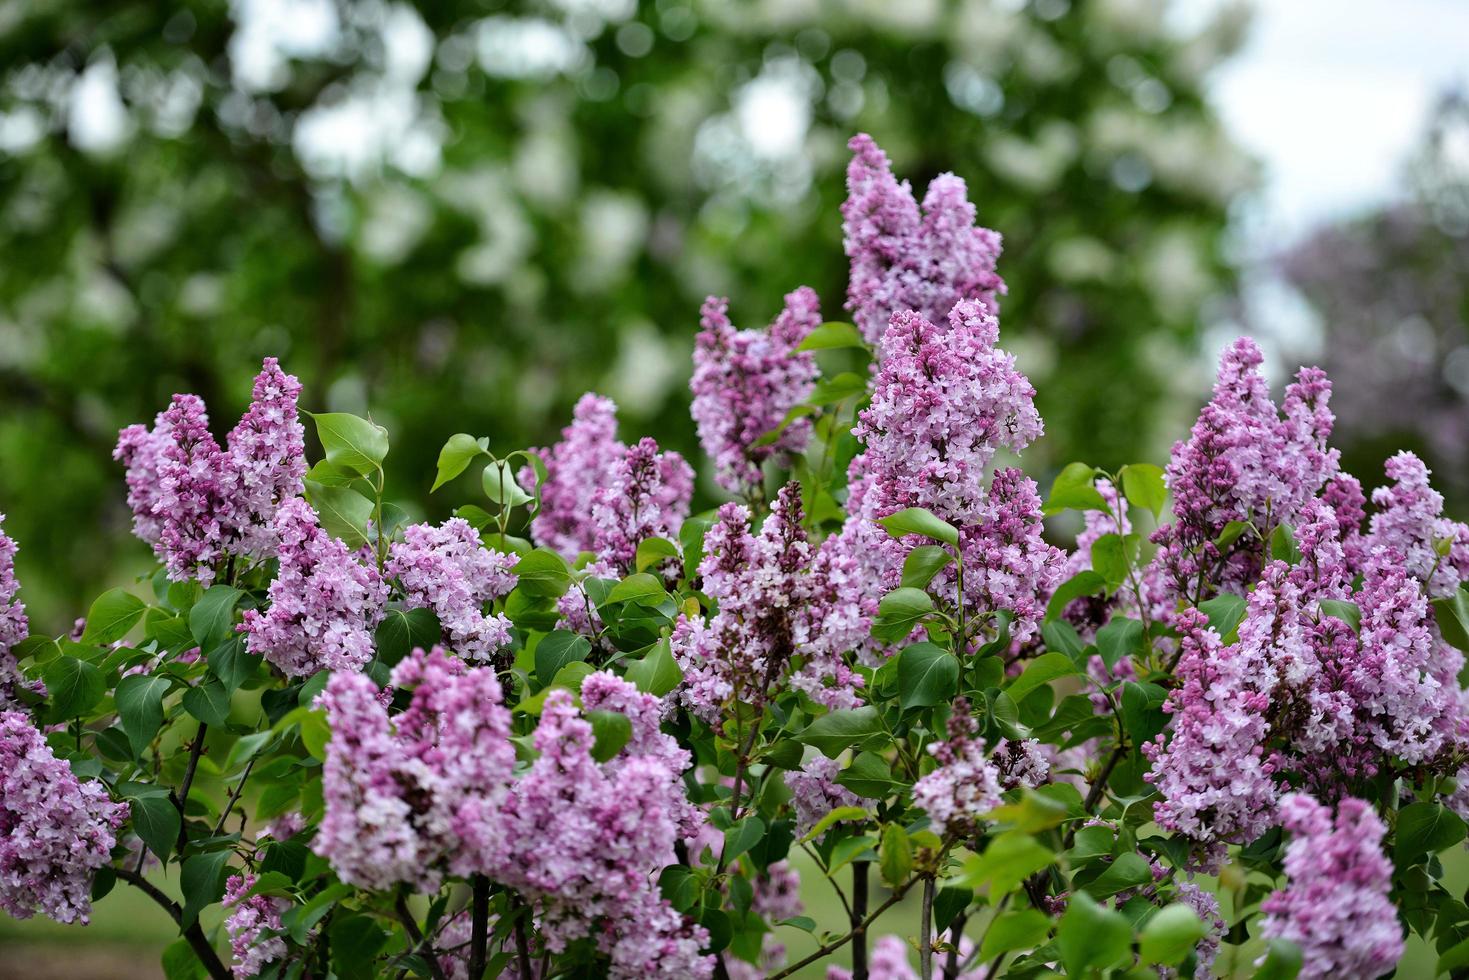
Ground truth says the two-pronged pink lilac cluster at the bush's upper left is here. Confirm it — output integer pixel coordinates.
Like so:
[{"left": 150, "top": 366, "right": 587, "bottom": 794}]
[{"left": 113, "top": 357, "right": 306, "bottom": 586}]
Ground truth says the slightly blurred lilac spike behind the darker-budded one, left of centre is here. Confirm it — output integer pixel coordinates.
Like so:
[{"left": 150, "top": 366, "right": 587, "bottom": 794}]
[{"left": 520, "top": 392, "right": 627, "bottom": 560}]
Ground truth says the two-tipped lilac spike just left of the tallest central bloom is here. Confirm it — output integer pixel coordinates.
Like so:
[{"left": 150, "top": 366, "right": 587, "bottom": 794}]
[{"left": 689, "top": 287, "right": 821, "bottom": 495}]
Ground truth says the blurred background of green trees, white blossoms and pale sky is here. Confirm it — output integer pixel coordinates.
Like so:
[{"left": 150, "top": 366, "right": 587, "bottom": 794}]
[{"left": 0, "top": 0, "right": 1469, "bottom": 977}]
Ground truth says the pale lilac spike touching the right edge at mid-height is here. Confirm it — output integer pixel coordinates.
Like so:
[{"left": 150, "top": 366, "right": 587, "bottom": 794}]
[{"left": 1363, "top": 453, "right": 1469, "bottom": 598}]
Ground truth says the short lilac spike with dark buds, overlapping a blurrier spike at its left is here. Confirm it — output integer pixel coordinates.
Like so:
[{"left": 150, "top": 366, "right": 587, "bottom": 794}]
[{"left": 582, "top": 436, "right": 693, "bottom": 572}]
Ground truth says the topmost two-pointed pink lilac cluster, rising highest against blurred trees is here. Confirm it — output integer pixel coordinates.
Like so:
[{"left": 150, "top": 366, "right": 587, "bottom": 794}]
[{"left": 842, "top": 134, "right": 1005, "bottom": 344}]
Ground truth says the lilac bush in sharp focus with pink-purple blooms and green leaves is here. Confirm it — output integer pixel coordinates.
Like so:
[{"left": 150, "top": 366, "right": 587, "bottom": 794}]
[{"left": 0, "top": 137, "right": 1469, "bottom": 980}]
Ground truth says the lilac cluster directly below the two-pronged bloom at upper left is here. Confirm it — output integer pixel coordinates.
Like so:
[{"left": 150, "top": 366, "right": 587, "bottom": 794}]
[{"left": 238, "top": 498, "right": 388, "bottom": 677}]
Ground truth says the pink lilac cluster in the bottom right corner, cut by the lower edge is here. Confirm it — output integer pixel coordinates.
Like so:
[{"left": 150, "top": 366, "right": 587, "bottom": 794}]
[{"left": 1260, "top": 793, "right": 1403, "bottom": 980}]
